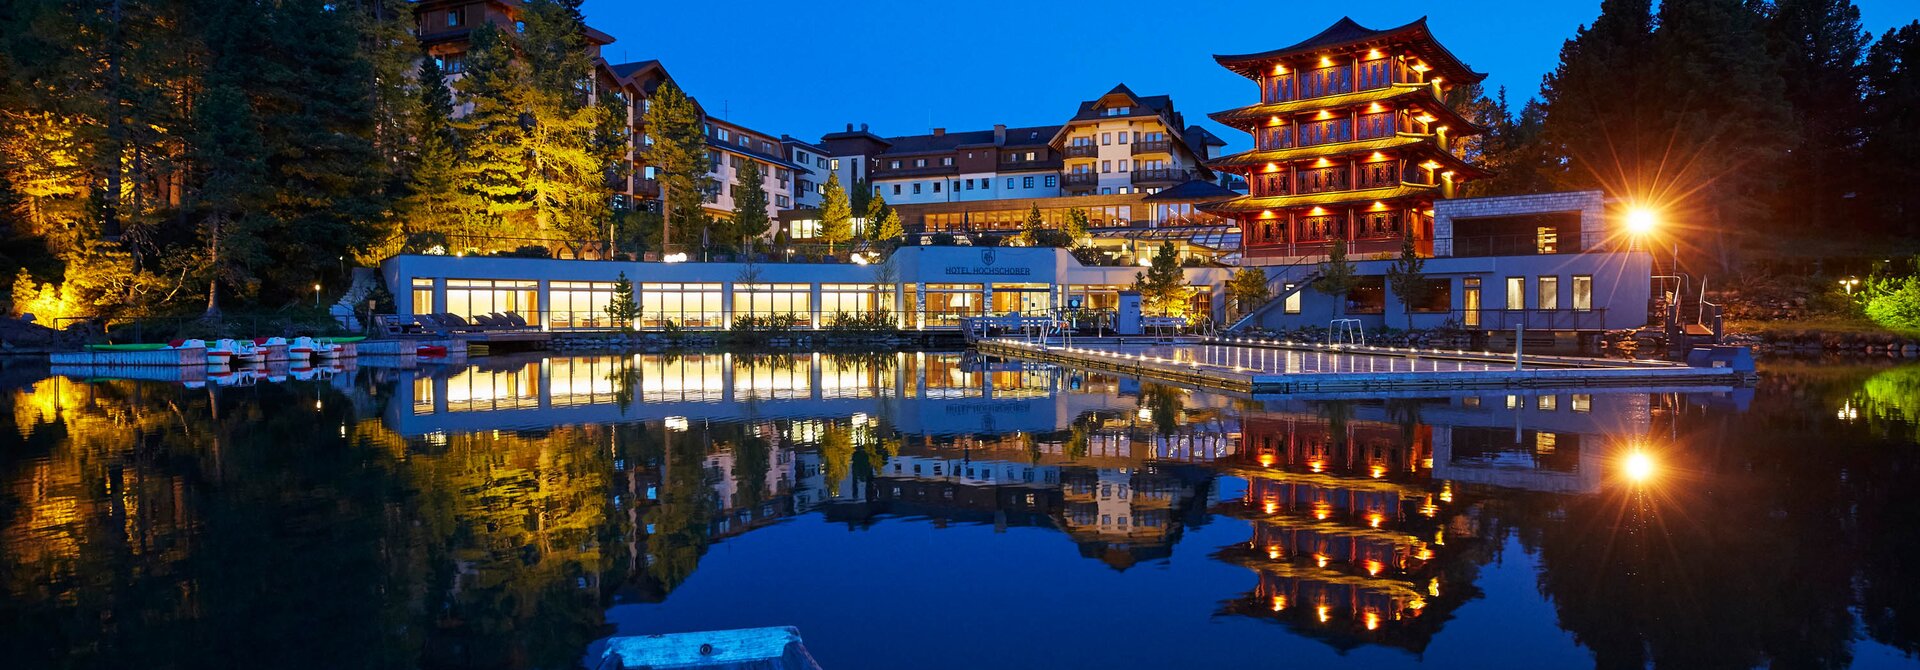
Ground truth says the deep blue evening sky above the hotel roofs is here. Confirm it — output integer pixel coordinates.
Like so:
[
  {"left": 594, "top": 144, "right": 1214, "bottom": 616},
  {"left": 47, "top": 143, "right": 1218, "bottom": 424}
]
[{"left": 584, "top": 0, "right": 1920, "bottom": 150}]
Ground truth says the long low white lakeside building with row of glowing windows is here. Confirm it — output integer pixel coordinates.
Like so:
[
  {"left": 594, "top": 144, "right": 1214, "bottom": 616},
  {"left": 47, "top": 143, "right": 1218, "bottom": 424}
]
[{"left": 380, "top": 246, "right": 1233, "bottom": 330}]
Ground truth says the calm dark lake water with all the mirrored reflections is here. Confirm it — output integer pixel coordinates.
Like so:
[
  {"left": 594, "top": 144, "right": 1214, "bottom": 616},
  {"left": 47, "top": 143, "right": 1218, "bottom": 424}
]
[{"left": 11, "top": 353, "right": 1920, "bottom": 670}]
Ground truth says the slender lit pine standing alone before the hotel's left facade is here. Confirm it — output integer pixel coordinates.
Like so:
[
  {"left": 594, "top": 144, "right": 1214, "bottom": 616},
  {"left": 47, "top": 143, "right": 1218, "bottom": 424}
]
[{"left": 641, "top": 81, "right": 710, "bottom": 244}]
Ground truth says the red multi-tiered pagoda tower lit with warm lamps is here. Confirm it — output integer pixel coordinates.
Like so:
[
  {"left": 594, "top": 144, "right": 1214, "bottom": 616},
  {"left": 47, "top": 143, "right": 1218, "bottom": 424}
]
[{"left": 1204, "top": 17, "right": 1488, "bottom": 265}]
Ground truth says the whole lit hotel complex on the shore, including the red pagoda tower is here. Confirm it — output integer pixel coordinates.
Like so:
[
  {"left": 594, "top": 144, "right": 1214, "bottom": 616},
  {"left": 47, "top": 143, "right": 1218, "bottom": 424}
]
[{"left": 382, "top": 11, "right": 1651, "bottom": 338}]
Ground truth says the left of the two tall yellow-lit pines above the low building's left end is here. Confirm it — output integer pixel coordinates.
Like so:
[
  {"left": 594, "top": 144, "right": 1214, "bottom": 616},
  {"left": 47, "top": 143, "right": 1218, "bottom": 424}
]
[{"left": 453, "top": 23, "right": 532, "bottom": 236}]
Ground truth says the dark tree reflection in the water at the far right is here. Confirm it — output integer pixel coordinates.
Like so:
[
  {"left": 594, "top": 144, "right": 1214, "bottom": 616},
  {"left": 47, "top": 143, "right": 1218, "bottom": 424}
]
[{"left": 1488, "top": 378, "right": 1920, "bottom": 668}]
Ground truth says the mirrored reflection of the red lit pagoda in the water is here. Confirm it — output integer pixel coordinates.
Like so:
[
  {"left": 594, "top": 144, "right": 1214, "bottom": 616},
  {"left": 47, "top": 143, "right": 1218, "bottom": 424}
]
[{"left": 1215, "top": 408, "right": 1475, "bottom": 651}]
